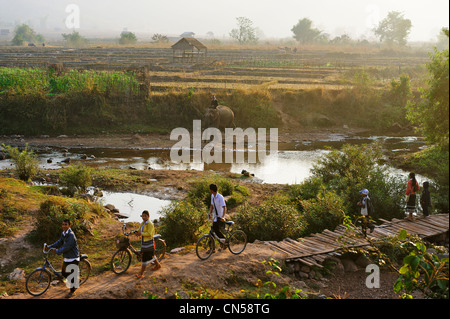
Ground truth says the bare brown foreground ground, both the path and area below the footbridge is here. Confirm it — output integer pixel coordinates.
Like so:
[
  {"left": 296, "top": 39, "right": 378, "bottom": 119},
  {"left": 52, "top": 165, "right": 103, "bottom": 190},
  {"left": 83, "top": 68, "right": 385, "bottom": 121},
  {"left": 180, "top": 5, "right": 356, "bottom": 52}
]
[{"left": 2, "top": 243, "right": 404, "bottom": 299}]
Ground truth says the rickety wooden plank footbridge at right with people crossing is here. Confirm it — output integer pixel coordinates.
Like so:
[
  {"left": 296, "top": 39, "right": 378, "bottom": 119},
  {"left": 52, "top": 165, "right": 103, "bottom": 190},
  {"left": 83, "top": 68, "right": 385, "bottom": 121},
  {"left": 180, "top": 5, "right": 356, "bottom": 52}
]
[{"left": 265, "top": 214, "right": 449, "bottom": 268}]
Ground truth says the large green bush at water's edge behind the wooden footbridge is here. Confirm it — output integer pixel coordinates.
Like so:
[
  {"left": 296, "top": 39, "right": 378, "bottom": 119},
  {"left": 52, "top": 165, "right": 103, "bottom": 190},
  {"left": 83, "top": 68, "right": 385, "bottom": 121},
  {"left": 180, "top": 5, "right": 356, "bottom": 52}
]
[{"left": 310, "top": 143, "right": 406, "bottom": 219}]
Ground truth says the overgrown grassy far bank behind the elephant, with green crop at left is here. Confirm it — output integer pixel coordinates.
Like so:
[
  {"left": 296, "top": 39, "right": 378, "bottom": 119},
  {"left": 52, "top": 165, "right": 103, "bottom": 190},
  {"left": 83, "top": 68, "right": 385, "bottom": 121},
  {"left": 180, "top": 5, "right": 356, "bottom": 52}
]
[{"left": 0, "top": 68, "right": 422, "bottom": 135}]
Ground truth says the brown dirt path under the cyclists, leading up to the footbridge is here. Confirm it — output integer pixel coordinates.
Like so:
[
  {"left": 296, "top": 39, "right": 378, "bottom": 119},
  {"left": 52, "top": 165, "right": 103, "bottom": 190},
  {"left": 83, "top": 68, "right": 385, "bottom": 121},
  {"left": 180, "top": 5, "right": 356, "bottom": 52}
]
[{"left": 8, "top": 243, "right": 291, "bottom": 299}]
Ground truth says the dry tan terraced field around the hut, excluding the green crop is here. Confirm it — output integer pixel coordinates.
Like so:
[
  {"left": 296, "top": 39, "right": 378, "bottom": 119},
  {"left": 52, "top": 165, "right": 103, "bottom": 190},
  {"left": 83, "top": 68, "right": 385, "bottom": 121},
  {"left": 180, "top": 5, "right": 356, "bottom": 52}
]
[{"left": 0, "top": 47, "right": 428, "bottom": 91}]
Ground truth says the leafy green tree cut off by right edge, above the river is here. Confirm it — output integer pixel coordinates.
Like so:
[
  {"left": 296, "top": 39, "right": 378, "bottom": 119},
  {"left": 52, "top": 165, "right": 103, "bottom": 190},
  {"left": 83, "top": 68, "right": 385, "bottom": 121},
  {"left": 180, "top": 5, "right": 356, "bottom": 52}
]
[{"left": 407, "top": 29, "right": 449, "bottom": 148}]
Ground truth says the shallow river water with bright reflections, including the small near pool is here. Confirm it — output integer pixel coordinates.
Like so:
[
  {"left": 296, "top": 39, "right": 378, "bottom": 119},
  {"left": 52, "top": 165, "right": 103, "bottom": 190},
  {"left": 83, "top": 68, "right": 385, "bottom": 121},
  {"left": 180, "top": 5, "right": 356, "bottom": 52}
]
[{"left": 0, "top": 134, "right": 425, "bottom": 221}]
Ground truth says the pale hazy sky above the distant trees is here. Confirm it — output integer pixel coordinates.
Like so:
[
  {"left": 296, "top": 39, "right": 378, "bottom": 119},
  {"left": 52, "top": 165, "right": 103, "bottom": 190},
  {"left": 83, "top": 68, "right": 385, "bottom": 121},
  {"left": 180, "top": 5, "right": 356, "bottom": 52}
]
[{"left": 0, "top": 0, "right": 449, "bottom": 41}]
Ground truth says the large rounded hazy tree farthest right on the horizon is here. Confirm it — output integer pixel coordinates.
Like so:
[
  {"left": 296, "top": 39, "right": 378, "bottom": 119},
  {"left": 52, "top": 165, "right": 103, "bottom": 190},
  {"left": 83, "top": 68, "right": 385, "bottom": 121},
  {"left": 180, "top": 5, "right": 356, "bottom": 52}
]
[{"left": 372, "top": 11, "right": 412, "bottom": 45}]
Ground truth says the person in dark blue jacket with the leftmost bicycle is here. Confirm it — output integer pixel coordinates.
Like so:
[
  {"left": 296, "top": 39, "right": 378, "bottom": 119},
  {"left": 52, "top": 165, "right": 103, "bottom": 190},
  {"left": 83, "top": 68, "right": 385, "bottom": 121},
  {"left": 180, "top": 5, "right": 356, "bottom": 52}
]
[{"left": 46, "top": 219, "right": 80, "bottom": 298}]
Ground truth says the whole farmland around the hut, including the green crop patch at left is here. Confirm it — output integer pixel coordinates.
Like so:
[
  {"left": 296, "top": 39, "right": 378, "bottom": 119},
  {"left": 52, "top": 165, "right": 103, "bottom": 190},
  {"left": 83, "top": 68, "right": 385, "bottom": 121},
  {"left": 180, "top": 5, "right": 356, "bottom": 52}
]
[{"left": 0, "top": 45, "right": 428, "bottom": 94}]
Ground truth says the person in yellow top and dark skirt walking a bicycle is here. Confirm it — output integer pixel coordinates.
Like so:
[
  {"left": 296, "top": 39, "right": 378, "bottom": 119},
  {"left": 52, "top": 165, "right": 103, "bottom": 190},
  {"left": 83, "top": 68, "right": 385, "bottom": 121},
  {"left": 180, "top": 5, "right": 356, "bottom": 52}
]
[{"left": 136, "top": 210, "right": 161, "bottom": 278}]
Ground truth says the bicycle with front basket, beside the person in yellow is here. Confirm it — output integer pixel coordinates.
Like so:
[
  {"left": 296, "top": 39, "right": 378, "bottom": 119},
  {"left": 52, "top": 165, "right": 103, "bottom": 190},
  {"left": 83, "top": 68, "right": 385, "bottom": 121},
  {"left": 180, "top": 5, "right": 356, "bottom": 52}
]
[{"left": 110, "top": 224, "right": 166, "bottom": 275}]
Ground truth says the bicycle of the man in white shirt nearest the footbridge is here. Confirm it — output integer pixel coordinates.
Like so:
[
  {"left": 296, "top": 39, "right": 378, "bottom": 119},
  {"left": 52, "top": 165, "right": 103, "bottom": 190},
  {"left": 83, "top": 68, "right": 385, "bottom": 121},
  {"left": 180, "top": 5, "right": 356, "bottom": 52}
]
[{"left": 195, "top": 221, "right": 247, "bottom": 260}]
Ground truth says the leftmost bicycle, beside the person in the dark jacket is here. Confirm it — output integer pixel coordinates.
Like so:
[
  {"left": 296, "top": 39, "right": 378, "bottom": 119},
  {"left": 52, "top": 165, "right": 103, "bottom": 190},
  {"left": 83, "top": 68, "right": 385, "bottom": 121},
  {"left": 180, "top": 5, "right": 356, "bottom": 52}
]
[{"left": 25, "top": 244, "right": 91, "bottom": 296}]
